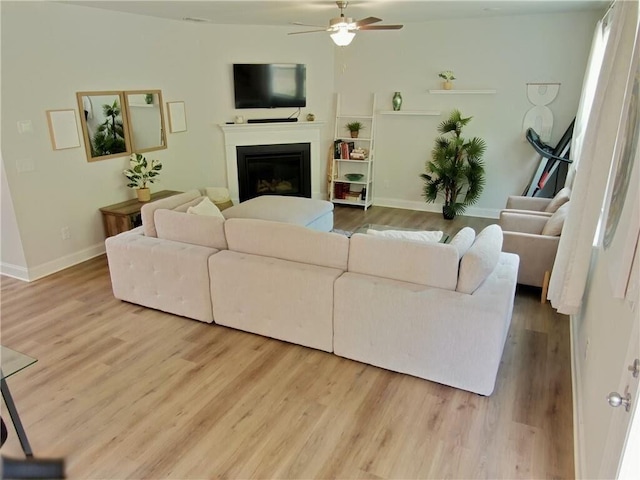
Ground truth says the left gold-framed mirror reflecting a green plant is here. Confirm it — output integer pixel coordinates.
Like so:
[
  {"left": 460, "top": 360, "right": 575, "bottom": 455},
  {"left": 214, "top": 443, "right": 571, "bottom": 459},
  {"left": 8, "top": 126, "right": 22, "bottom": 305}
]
[{"left": 76, "top": 92, "right": 131, "bottom": 162}]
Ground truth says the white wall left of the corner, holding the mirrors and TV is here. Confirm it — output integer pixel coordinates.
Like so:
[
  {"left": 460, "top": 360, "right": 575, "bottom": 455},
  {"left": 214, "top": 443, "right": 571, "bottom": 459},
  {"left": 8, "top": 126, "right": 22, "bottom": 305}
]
[{"left": 1, "top": 2, "right": 333, "bottom": 279}]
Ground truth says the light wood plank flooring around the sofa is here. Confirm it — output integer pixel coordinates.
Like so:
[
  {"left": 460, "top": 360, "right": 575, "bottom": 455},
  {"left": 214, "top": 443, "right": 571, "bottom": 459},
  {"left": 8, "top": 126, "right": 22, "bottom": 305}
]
[{"left": 1, "top": 207, "right": 574, "bottom": 479}]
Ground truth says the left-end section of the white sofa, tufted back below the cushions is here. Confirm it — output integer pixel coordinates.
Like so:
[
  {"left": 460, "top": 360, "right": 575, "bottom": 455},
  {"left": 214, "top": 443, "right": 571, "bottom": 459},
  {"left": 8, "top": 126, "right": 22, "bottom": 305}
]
[{"left": 106, "top": 227, "right": 218, "bottom": 323}]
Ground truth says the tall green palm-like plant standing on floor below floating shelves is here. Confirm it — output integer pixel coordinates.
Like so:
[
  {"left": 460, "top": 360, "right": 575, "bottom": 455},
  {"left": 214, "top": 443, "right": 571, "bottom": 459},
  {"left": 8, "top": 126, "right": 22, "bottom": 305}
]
[{"left": 420, "top": 110, "right": 487, "bottom": 220}]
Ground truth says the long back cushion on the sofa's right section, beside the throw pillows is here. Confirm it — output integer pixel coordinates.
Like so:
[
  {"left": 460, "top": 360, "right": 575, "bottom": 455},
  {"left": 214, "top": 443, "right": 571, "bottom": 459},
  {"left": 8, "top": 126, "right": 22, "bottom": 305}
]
[{"left": 349, "top": 233, "right": 458, "bottom": 290}]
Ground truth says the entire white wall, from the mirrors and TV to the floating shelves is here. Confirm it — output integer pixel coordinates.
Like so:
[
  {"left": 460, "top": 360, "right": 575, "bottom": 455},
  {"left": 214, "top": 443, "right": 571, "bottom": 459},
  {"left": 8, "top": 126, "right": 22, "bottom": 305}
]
[{"left": 0, "top": 2, "right": 597, "bottom": 279}]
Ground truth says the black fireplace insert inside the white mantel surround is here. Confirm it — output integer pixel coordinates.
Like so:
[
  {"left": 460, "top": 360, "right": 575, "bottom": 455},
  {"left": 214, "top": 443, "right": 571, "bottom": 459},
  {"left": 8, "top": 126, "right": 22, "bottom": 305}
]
[{"left": 236, "top": 143, "right": 311, "bottom": 202}]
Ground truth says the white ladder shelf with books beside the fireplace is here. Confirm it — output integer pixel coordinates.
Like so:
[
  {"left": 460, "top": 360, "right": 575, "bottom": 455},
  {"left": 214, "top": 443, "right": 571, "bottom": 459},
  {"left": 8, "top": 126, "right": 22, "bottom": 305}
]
[{"left": 329, "top": 94, "right": 376, "bottom": 210}]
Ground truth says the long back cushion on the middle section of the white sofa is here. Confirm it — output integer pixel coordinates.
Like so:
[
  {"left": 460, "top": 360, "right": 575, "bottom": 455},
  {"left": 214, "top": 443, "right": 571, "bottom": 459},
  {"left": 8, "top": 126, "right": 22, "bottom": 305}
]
[{"left": 224, "top": 218, "right": 349, "bottom": 270}]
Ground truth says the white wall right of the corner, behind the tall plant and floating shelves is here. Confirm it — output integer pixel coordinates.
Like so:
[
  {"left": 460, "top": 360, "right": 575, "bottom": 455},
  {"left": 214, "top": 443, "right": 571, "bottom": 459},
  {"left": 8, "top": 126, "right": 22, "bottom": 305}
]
[{"left": 335, "top": 12, "right": 600, "bottom": 216}]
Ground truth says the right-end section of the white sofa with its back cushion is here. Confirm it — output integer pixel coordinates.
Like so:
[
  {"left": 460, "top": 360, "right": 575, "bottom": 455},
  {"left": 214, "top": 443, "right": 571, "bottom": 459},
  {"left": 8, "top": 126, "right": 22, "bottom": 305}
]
[{"left": 334, "top": 231, "right": 519, "bottom": 395}]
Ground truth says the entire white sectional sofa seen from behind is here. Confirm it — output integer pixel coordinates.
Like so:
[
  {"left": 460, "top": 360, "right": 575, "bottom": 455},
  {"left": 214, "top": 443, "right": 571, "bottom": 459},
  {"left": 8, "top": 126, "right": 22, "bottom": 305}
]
[{"left": 106, "top": 191, "right": 518, "bottom": 395}]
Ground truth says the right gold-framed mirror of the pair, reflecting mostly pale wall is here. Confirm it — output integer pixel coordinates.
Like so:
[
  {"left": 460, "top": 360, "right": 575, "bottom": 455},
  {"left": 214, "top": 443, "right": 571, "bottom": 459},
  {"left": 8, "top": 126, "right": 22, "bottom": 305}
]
[{"left": 124, "top": 90, "right": 167, "bottom": 153}]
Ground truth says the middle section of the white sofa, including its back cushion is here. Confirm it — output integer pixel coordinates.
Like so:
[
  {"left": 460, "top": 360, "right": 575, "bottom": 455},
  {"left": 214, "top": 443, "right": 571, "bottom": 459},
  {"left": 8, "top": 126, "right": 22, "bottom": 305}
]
[{"left": 209, "top": 219, "right": 349, "bottom": 352}]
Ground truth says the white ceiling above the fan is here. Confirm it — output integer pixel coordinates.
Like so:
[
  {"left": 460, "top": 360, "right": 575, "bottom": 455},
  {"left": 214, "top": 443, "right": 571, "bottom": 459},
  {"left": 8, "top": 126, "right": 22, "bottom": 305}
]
[{"left": 61, "top": 0, "right": 611, "bottom": 27}]
